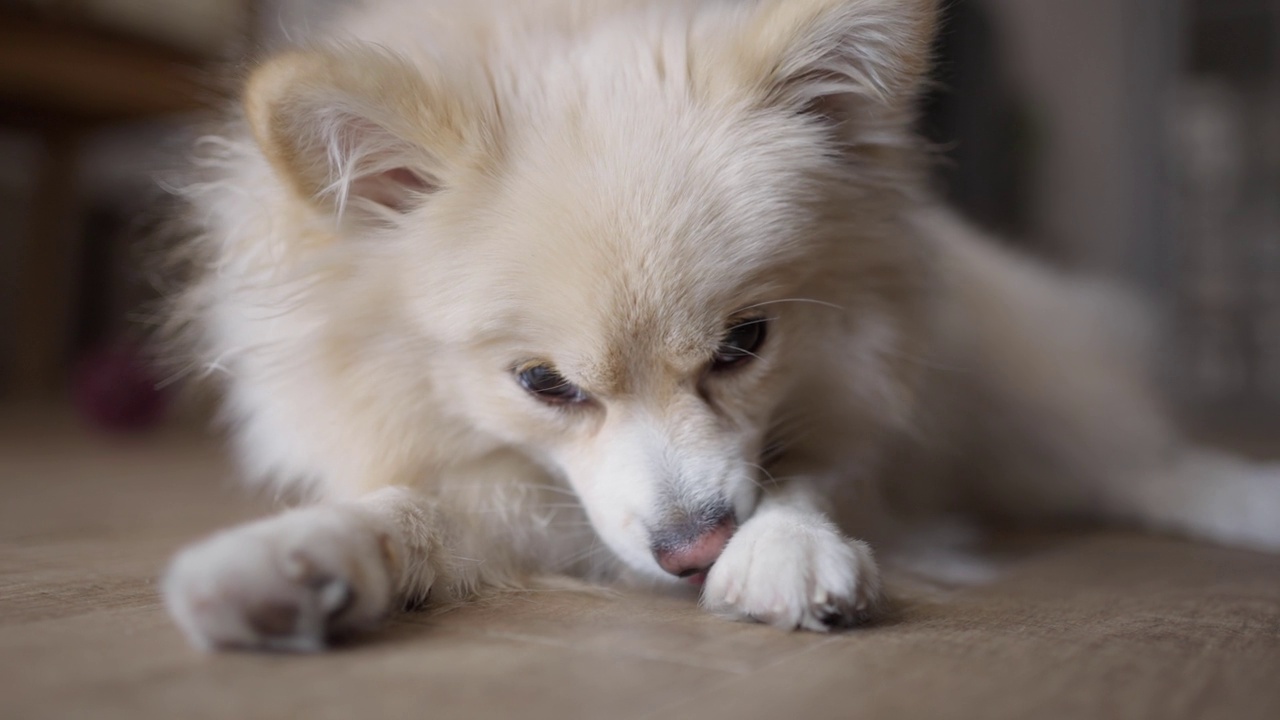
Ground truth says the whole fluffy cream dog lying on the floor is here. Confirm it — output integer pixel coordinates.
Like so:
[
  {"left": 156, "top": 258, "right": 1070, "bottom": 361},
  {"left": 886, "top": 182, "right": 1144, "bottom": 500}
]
[{"left": 163, "top": 0, "right": 1280, "bottom": 651}]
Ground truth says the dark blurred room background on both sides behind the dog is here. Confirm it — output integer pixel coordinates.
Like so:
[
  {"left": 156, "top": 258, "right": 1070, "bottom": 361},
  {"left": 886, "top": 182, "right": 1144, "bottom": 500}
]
[{"left": 0, "top": 0, "right": 1280, "bottom": 428}]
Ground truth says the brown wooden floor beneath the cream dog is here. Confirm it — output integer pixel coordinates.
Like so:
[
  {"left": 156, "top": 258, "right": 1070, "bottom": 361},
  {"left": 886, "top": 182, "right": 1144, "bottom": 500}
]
[{"left": 0, "top": 411, "right": 1280, "bottom": 720}]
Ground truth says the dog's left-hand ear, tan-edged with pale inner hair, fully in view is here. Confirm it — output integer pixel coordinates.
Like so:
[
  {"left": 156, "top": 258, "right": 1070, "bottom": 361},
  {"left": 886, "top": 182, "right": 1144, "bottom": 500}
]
[{"left": 244, "top": 47, "right": 465, "bottom": 219}]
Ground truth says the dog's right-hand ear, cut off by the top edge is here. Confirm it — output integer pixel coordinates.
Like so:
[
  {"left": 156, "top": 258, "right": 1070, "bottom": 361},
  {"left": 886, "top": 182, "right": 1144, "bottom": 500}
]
[{"left": 713, "top": 0, "right": 938, "bottom": 124}]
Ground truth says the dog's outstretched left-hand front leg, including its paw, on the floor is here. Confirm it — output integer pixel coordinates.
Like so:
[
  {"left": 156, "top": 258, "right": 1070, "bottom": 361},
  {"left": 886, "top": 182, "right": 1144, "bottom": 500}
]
[{"left": 164, "top": 468, "right": 581, "bottom": 651}]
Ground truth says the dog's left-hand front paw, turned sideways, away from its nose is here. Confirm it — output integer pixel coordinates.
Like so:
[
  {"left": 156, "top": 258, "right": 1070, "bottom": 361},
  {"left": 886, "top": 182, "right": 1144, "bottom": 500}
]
[{"left": 163, "top": 507, "right": 396, "bottom": 652}]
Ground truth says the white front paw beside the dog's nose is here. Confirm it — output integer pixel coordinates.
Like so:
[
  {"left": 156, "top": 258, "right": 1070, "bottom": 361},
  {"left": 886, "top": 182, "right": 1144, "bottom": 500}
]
[{"left": 703, "top": 511, "right": 879, "bottom": 632}]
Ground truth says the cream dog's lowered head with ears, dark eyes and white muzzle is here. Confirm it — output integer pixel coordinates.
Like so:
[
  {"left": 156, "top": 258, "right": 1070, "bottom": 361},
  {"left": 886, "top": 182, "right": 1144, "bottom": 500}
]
[{"left": 246, "top": 0, "right": 933, "bottom": 575}]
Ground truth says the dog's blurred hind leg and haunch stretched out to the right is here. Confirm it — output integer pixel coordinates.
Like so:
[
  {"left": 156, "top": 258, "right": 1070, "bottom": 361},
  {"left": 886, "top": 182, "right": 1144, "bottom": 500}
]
[{"left": 931, "top": 210, "right": 1280, "bottom": 550}]
